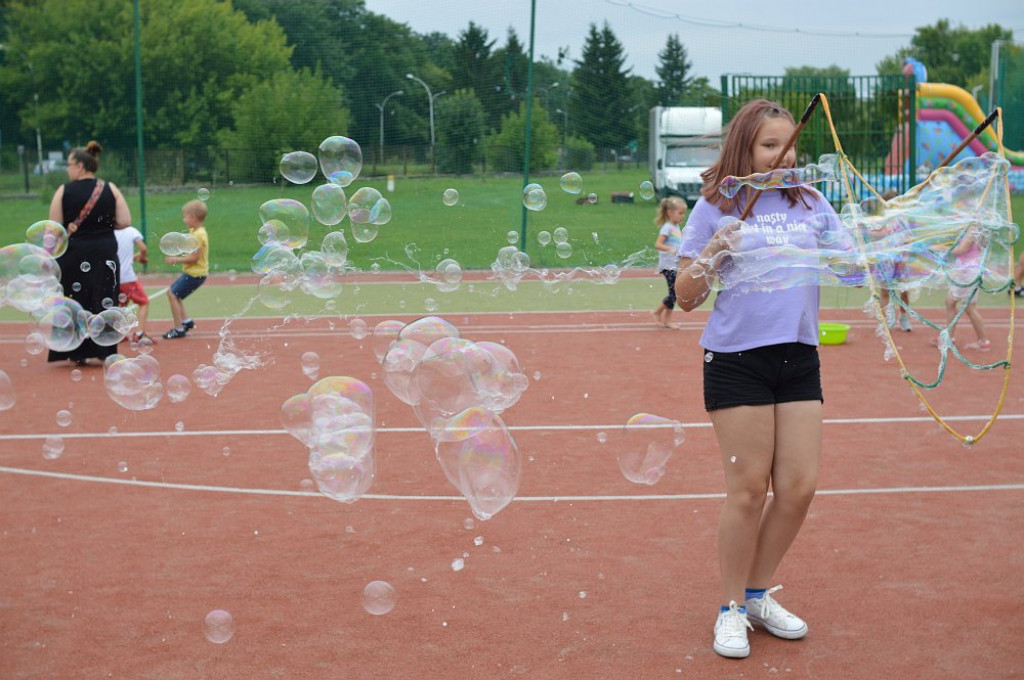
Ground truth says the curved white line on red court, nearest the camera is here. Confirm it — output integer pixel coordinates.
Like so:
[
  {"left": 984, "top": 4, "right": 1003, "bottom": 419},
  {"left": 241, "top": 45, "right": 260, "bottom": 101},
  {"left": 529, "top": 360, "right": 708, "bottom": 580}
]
[{"left": 0, "top": 466, "right": 1024, "bottom": 503}]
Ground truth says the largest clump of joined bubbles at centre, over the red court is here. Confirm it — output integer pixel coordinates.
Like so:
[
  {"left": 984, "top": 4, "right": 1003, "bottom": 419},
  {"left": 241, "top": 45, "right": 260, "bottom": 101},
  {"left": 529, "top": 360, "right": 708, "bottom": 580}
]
[{"left": 373, "top": 316, "right": 528, "bottom": 519}]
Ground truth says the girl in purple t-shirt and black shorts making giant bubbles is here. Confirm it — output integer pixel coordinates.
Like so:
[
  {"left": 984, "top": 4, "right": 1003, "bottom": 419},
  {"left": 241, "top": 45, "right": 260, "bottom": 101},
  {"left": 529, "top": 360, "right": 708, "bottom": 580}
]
[{"left": 676, "top": 99, "right": 837, "bottom": 657}]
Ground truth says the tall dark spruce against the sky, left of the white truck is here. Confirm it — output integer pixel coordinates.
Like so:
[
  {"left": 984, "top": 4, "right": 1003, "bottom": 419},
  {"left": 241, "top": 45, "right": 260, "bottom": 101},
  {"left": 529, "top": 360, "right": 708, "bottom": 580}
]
[{"left": 569, "top": 23, "right": 636, "bottom": 148}]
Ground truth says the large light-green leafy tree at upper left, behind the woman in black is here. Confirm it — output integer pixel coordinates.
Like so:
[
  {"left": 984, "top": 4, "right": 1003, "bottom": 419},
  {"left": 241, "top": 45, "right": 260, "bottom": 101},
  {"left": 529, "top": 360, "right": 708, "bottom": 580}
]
[{"left": 0, "top": 0, "right": 289, "bottom": 146}]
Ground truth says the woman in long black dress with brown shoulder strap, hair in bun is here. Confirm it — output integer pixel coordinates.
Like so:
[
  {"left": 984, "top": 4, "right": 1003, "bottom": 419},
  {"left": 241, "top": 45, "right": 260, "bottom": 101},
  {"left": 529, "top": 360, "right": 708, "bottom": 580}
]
[{"left": 49, "top": 141, "right": 131, "bottom": 365}]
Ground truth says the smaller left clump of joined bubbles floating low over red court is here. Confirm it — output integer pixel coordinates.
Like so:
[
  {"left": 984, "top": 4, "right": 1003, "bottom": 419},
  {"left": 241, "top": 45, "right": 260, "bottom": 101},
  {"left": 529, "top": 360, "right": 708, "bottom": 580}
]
[{"left": 281, "top": 376, "right": 376, "bottom": 503}]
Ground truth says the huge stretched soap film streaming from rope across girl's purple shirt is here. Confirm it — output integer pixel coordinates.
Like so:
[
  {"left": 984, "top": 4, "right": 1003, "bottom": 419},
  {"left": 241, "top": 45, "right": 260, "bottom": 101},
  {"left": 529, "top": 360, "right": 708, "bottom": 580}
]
[{"left": 689, "top": 155, "right": 1020, "bottom": 299}]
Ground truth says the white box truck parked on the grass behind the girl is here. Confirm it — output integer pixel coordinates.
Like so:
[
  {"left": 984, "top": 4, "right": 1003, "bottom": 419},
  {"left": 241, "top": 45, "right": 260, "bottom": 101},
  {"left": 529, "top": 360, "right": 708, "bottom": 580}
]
[{"left": 648, "top": 107, "right": 722, "bottom": 208}]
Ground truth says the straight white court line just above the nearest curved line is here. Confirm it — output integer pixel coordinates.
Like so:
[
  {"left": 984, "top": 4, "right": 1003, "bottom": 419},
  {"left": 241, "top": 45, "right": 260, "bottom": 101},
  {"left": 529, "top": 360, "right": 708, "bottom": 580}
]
[{"left": 0, "top": 414, "right": 1024, "bottom": 441}]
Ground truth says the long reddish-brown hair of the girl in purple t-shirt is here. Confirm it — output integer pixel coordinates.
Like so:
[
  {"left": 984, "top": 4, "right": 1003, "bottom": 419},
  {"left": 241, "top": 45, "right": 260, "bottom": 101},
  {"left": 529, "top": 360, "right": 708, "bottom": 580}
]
[{"left": 700, "top": 98, "right": 808, "bottom": 212}]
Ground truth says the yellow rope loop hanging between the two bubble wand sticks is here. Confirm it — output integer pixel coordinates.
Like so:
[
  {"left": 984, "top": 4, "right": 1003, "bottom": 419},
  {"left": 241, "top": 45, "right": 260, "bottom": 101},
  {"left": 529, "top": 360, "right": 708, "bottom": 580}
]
[{"left": 820, "top": 93, "right": 1016, "bottom": 445}]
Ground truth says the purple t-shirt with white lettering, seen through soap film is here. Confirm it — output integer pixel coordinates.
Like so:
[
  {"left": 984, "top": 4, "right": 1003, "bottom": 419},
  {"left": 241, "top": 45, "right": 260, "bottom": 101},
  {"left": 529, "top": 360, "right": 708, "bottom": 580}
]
[{"left": 679, "top": 189, "right": 839, "bottom": 352}]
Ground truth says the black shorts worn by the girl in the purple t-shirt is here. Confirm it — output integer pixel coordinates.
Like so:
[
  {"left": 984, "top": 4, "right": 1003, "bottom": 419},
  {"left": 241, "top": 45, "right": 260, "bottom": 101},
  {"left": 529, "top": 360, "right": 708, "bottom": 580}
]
[{"left": 703, "top": 342, "right": 824, "bottom": 411}]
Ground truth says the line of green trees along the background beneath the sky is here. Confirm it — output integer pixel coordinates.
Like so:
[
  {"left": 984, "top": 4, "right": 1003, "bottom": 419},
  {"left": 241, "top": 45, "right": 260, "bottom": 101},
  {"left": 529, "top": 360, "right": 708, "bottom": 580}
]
[{"left": 0, "top": 0, "right": 1012, "bottom": 180}]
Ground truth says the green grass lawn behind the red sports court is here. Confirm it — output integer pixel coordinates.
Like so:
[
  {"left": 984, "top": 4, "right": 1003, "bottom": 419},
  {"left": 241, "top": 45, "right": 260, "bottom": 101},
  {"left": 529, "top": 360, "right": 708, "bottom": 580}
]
[{"left": 0, "top": 170, "right": 656, "bottom": 271}]
